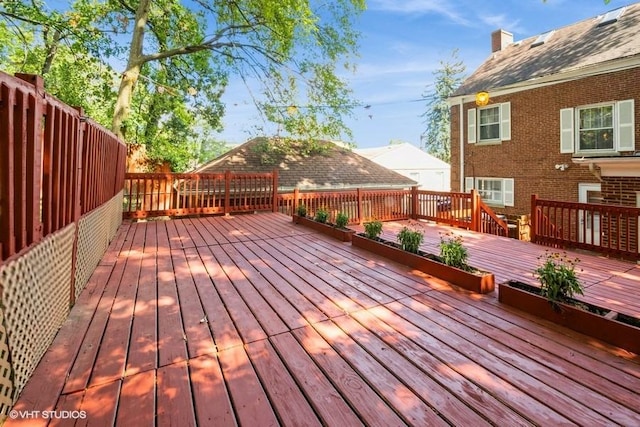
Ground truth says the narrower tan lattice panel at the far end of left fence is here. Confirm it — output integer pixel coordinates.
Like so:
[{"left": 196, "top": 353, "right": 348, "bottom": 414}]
[{"left": 74, "top": 192, "right": 123, "bottom": 299}]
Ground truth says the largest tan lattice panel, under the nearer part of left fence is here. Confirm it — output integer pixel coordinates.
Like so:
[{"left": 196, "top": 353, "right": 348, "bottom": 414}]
[{"left": 0, "top": 224, "right": 75, "bottom": 397}]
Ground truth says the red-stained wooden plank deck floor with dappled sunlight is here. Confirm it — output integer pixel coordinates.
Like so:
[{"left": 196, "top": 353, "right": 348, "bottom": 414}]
[{"left": 7, "top": 214, "right": 640, "bottom": 426}]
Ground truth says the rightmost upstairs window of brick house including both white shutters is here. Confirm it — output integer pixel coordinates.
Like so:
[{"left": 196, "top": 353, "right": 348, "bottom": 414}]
[{"left": 560, "top": 99, "right": 635, "bottom": 155}]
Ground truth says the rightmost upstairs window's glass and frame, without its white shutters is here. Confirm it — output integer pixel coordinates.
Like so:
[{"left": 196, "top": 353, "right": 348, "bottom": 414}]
[{"left": 578, "top": 105, "right": 614, "bottom": 151}]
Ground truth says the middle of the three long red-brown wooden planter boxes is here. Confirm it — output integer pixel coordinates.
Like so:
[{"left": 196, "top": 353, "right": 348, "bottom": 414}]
[{"left": 351, "top": 234, "right": 495, "bottom": 294}]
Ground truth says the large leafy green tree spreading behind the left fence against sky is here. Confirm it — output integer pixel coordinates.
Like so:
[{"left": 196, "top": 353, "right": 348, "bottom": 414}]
[{"left": 0, "top": 0, "right": 365, "bottom": 170}]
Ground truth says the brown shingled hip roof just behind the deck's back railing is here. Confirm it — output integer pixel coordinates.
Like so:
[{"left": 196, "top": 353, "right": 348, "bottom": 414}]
[{"left": 197, "top": 138, "right": 417, "bottom": 191}]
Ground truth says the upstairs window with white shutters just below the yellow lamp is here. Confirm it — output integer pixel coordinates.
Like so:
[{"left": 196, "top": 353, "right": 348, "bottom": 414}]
[{"left": 467, "top": 102, "right": 511, "bottom": 144}]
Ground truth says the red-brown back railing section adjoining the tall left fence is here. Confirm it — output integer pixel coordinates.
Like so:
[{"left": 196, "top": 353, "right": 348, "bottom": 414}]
[{"left": 123, "top": 170, "right": 278, "bottom": 218}]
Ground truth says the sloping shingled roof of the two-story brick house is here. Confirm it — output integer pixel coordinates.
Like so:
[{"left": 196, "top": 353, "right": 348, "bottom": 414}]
[{"left": 453, "top": 3, "right": 640, "bottom": 97}]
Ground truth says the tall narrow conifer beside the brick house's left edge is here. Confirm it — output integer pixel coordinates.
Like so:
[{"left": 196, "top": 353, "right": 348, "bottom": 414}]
[{"left": 421, "top": 50, "right": 466, "bottom": 163}]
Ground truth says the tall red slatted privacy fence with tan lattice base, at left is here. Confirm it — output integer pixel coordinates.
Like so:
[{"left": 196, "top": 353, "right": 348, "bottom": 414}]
[{"left": 0, "top": 72, "right": 127, "bottom": 416}]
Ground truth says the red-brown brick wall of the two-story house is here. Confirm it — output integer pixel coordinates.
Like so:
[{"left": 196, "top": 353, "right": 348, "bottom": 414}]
[{"left": 451, "top": 68, "right": 640, "bottom": 214}]
